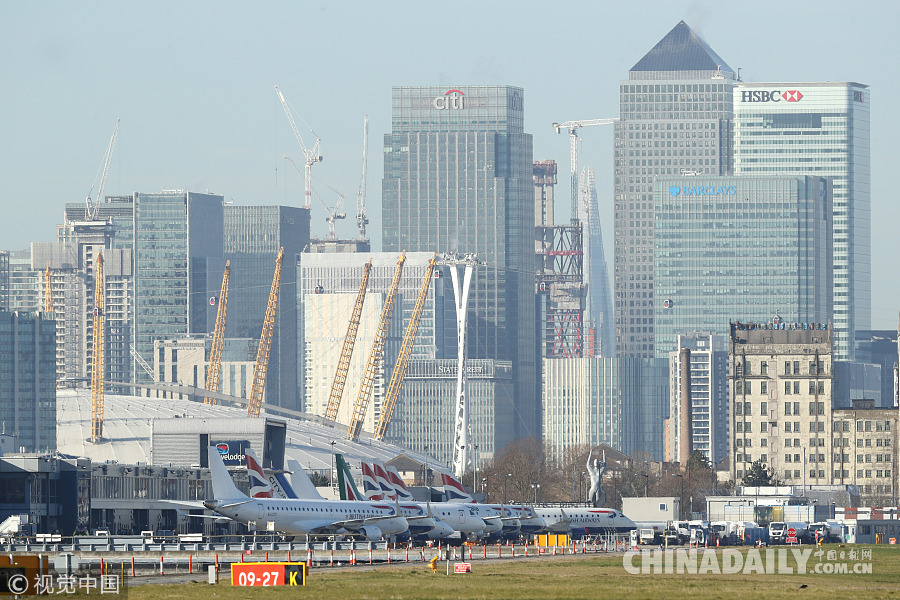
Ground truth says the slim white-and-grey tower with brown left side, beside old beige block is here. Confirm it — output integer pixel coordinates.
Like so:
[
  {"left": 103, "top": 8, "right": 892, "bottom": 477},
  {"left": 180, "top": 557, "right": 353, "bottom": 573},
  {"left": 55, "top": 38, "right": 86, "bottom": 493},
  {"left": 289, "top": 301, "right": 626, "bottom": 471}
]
[{"left": 665, "top": 332, "right": 729, "bottom": 464}]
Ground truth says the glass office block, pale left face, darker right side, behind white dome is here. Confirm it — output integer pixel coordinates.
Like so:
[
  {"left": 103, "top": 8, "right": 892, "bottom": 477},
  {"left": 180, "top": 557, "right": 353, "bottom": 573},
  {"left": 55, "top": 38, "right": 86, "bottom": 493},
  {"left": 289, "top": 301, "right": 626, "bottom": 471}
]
[{"left": 132, "top": 191, "right": 223, "bottom": 382}]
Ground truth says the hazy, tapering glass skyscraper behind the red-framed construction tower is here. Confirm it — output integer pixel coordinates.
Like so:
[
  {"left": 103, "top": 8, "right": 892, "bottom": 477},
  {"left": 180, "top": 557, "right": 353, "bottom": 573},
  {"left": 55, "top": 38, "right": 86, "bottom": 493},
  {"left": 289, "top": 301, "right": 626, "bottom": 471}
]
[{"left": 579, "top": 167, "right": 615, "bottom": 358}]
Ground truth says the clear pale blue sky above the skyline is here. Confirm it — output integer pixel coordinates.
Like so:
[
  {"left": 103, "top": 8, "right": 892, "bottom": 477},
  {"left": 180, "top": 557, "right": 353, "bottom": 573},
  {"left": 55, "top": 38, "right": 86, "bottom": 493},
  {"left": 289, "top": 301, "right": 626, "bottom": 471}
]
[{"left": 0, "top": 0, "right": 900, "bottom": 329}]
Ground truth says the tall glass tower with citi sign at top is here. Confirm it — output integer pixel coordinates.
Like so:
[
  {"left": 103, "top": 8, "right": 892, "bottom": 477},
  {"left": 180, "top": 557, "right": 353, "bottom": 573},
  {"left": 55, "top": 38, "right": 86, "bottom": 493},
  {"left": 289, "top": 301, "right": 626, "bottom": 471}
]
[{"left": 382, "top": 86, "right": 540, "bottom": 438}]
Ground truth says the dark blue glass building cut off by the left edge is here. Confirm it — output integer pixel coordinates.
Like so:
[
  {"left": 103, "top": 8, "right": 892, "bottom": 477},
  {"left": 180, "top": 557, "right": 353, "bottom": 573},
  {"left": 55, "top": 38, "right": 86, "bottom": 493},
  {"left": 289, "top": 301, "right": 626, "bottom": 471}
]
[{"left": 0, "top": 311, "right": 56, "bottom": 452}]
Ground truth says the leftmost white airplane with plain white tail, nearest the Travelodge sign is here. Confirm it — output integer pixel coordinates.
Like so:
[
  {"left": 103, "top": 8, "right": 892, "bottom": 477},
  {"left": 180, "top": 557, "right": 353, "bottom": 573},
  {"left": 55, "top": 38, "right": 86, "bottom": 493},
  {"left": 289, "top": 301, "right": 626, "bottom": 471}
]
[{"left": 203, "top": 446, "right": 409, "bottom": 541}]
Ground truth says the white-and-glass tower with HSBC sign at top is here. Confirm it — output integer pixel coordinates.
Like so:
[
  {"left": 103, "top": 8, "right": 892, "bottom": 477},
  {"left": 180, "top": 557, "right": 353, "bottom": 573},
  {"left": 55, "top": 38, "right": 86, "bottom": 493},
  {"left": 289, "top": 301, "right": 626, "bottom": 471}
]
[{"left": 733, "top": 82, "right": 872, "bottom": 360}]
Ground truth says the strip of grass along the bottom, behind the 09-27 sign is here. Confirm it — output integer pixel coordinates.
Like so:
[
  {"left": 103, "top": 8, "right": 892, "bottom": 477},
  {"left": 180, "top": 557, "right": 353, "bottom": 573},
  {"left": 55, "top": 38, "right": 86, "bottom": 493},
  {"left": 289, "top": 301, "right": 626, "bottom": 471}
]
[{"left": 121, "top": 546, "right": 900, "bottom": 600}]
